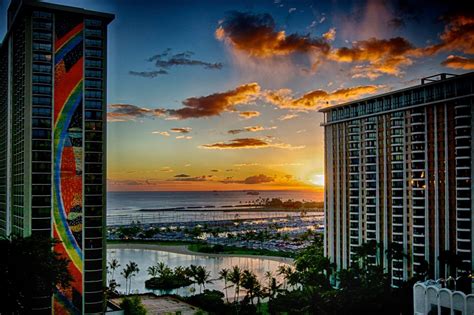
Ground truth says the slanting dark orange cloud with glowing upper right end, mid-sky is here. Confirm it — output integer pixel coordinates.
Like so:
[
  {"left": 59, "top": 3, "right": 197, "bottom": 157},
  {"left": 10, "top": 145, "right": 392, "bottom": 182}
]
[{"left": 168, "top": 83, "right": 260, "bottom": 119}]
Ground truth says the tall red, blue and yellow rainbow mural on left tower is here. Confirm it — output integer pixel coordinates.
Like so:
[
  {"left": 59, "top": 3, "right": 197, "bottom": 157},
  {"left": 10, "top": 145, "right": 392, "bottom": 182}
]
[{"left": 53, "top": 14, "right": 84, "bottom": 314}]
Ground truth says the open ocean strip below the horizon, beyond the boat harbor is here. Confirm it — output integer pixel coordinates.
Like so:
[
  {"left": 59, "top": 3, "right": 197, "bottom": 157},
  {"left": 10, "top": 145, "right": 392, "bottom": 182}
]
[{"left": 107, "top": 190, "right": 323, "bottom": 214}]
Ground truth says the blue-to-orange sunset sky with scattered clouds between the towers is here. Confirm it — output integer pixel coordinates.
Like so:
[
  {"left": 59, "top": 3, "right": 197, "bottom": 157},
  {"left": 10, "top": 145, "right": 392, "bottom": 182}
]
[{"left": 0, "top": 0, "right": 474, "bottom": 191}]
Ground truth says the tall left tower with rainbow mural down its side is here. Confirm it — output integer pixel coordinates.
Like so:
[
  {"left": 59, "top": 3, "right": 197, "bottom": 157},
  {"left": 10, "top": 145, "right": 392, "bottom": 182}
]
[{"left": 0, "top": 0, "right": 114, "bottom": 314}]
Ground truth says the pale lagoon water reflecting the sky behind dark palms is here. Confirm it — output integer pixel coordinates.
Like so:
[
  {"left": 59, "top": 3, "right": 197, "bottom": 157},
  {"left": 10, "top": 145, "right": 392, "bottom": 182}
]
[{"left": 107, "top": 249, "right": 283, "bottom": 296}]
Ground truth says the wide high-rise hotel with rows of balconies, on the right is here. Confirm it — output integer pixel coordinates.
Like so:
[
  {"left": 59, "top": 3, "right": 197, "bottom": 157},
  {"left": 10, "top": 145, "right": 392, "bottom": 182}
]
[{"left": 321, "top": 72, "right": 474, "bottom": 286}]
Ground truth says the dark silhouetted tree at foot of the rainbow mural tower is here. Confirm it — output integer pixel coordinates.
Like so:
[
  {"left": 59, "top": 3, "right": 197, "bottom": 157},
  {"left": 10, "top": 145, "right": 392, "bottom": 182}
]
[{"left": 0, "top": 236, "right": 72, "bottom": 314}]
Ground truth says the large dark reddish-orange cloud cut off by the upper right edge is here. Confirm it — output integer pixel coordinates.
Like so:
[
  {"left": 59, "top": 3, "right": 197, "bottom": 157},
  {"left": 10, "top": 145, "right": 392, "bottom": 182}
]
[{"left": 423, "top": 15, "right": 474, "bottom": 55}]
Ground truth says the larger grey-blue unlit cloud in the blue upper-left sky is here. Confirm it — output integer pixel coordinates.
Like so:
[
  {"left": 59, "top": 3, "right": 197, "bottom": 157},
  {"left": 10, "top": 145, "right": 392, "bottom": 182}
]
[{"left": 147, "top": 49, "right": 222, "bottom": 70}]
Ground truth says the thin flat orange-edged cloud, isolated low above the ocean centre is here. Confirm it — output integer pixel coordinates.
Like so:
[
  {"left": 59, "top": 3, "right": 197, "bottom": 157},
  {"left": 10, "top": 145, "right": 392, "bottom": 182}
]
[{"left": 199, "top": 138, "right": 305, "bottom": 150}]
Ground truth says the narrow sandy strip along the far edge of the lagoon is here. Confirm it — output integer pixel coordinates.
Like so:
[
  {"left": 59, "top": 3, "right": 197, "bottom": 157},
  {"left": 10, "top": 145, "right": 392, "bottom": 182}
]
[{"left": 107, "top": 243, "right": 293, "bottom": 265}]
